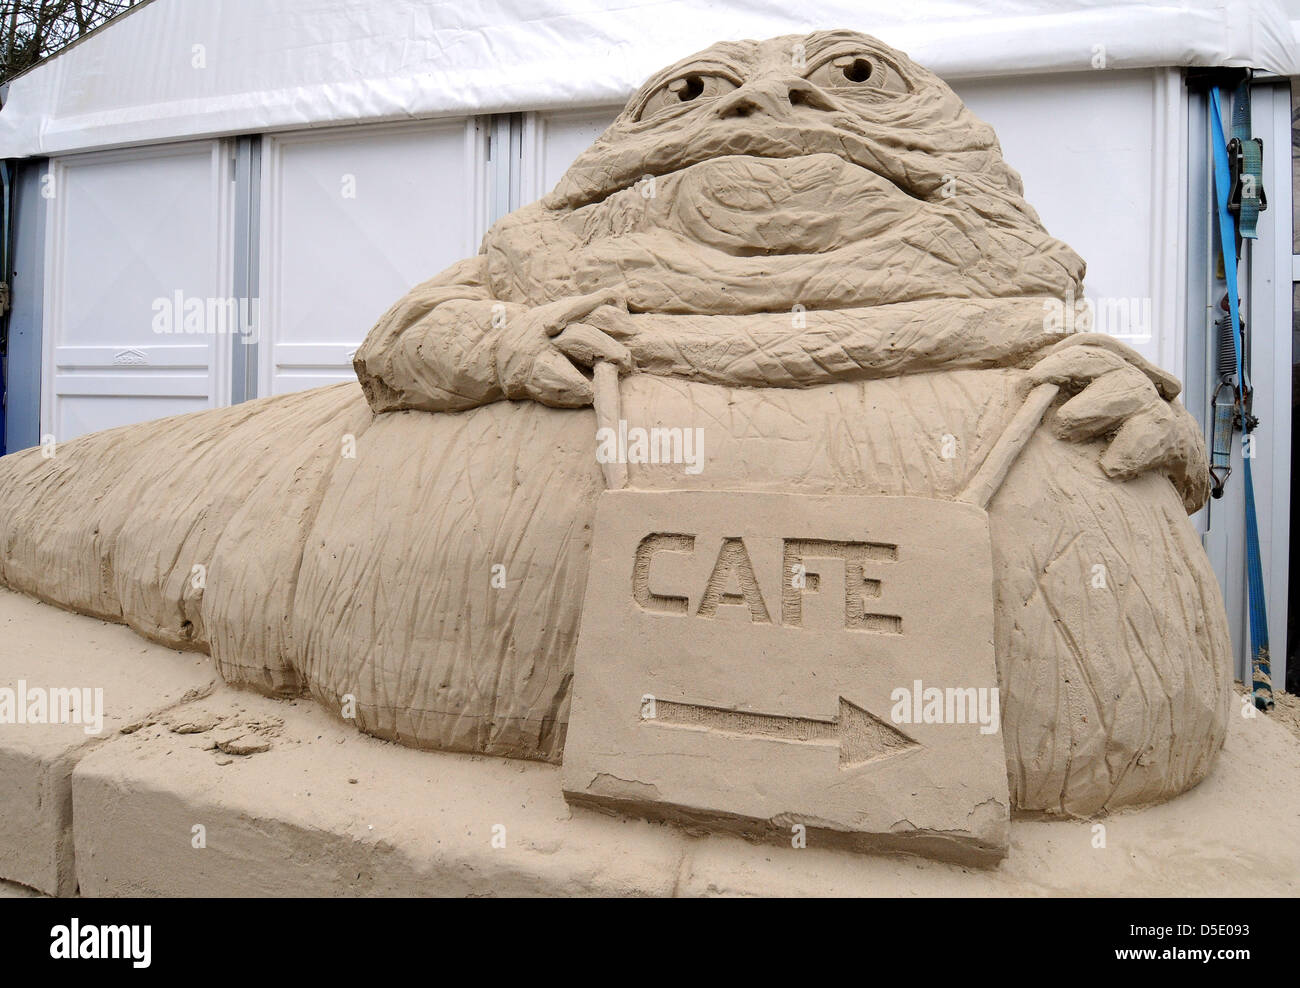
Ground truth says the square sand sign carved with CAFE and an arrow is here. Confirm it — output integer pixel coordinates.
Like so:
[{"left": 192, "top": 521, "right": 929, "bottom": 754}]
[{"left": 563, "top": 491, "right": 1010, "bottom": 865}]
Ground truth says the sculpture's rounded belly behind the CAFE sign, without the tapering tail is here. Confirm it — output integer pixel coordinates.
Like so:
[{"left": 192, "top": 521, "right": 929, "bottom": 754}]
[{"left": 295, "top": 371, "right": 1229, "bottom": 813}]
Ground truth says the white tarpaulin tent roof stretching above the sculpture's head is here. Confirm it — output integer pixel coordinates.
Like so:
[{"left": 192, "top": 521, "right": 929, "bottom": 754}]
[{"left": 0, "top": 0, "right": 1300, "bottom": 157}]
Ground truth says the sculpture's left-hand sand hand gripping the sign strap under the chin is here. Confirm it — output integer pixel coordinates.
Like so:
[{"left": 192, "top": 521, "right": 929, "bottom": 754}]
[{"left": 497, "top": 291, "right": 632, "bottom": 408}]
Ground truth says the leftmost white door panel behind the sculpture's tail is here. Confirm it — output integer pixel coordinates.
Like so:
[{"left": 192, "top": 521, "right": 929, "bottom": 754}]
[{"left": 42, "top": 140, "right": 230, "bottom": 441}]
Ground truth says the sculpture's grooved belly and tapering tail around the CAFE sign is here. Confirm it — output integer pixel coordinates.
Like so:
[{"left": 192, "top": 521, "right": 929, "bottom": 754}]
[{"left": 0, "top": 371, "right": 1231, "bottom": 813}]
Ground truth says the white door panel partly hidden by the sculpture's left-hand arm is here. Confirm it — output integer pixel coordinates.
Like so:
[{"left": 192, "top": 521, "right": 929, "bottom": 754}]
[{"left": 259, "top": 117, "right": 484, "bottom": 395}]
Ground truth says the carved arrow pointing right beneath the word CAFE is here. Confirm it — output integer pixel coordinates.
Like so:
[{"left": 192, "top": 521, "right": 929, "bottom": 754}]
[{"left": 642, "top": 697, "right": 919, "bottom": 768}]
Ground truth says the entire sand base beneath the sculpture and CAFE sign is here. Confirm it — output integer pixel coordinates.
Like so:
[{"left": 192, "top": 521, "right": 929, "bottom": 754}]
[{"left": 0, "top": 590, "right": 1300, "bottom": 896}]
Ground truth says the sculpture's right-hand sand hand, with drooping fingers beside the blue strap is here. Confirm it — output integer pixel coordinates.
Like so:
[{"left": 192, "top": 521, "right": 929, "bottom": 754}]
[{"left": 1030, "top": 333, "right": 1210, "bottom": 514}]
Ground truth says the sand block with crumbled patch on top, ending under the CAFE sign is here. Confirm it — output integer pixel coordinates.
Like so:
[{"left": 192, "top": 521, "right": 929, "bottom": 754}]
[{"left": 73, "top": 688, "right": 684, "bottom": 897}]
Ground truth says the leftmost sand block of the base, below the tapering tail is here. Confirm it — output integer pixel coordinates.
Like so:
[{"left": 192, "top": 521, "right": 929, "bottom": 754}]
[{"left": 0, "top": 590, "right": 216, "bottom": 894}]
